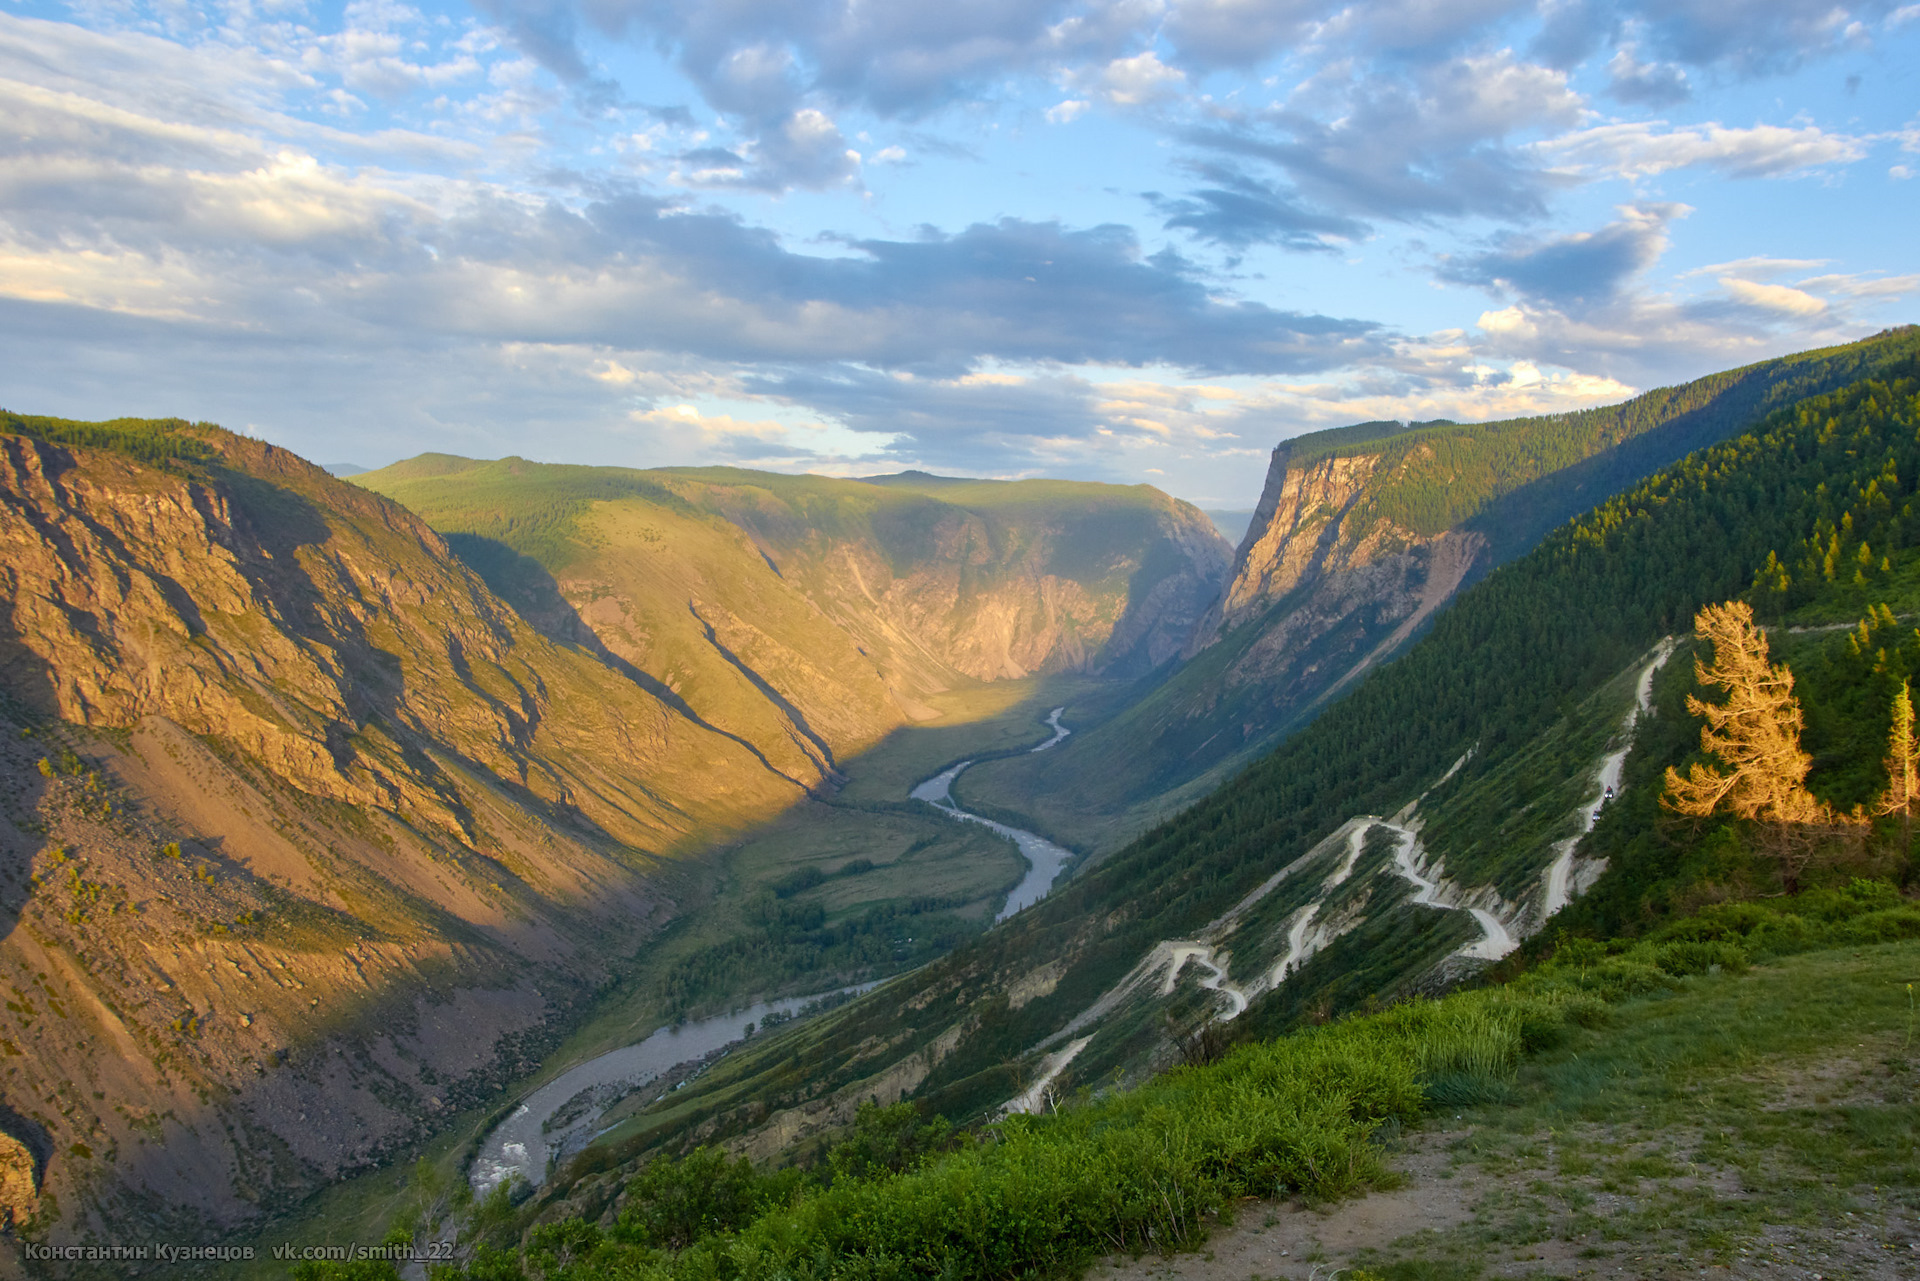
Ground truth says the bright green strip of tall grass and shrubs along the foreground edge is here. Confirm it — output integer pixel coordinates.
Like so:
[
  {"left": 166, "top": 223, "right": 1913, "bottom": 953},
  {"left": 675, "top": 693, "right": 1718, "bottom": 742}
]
[{"left": 370, "top": 989, "right": 1574, "bottom": 1281}]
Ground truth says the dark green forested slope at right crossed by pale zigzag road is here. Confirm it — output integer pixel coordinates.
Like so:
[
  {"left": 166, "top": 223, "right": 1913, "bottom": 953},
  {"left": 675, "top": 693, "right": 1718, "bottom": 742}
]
[{"left": 560, "top": 345, "right": 1920, "bottom": 1175}]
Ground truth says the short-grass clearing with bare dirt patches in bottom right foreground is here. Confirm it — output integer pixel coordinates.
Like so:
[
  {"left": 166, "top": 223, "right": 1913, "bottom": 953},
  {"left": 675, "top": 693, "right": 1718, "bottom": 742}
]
[{"left": 1089, "top": 943, "right": 1920, "bottom": 1281}]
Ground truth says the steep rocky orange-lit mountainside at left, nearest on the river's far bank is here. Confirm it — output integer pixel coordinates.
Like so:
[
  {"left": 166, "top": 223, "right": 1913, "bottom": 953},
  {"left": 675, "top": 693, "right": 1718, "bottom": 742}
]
[{"left": 0, "top": 428, "right": 803, "bottom": 1229}]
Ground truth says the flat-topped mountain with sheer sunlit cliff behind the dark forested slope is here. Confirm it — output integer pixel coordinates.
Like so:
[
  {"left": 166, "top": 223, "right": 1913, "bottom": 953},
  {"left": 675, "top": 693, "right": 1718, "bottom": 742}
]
[{"left": 962, "top": 326, "right": 1920, "bottom": 849}]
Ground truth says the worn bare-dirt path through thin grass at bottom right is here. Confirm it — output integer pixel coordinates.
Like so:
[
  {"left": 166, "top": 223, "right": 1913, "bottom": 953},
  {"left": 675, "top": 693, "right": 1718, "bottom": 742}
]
[{"left": 1087, "top": 1122, "right": 1920, "bottom": 1281}]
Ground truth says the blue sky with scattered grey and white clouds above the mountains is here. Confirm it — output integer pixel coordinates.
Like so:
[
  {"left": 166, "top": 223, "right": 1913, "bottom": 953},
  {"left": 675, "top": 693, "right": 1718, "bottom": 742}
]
[{"left": 0, "top": 0, "right": 1920, "bottom": 509}]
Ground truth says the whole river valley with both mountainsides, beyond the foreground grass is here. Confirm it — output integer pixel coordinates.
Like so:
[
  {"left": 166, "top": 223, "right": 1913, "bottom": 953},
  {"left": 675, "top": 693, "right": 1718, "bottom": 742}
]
[{"left": 0, "top": 330, "right": 1920, "bottom": 1275}]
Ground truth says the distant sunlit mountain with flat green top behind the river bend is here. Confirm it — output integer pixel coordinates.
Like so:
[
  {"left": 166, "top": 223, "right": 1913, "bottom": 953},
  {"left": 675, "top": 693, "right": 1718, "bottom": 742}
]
[{"left": 355, "top": 455, "right": 1227, "bottom": 778}]
